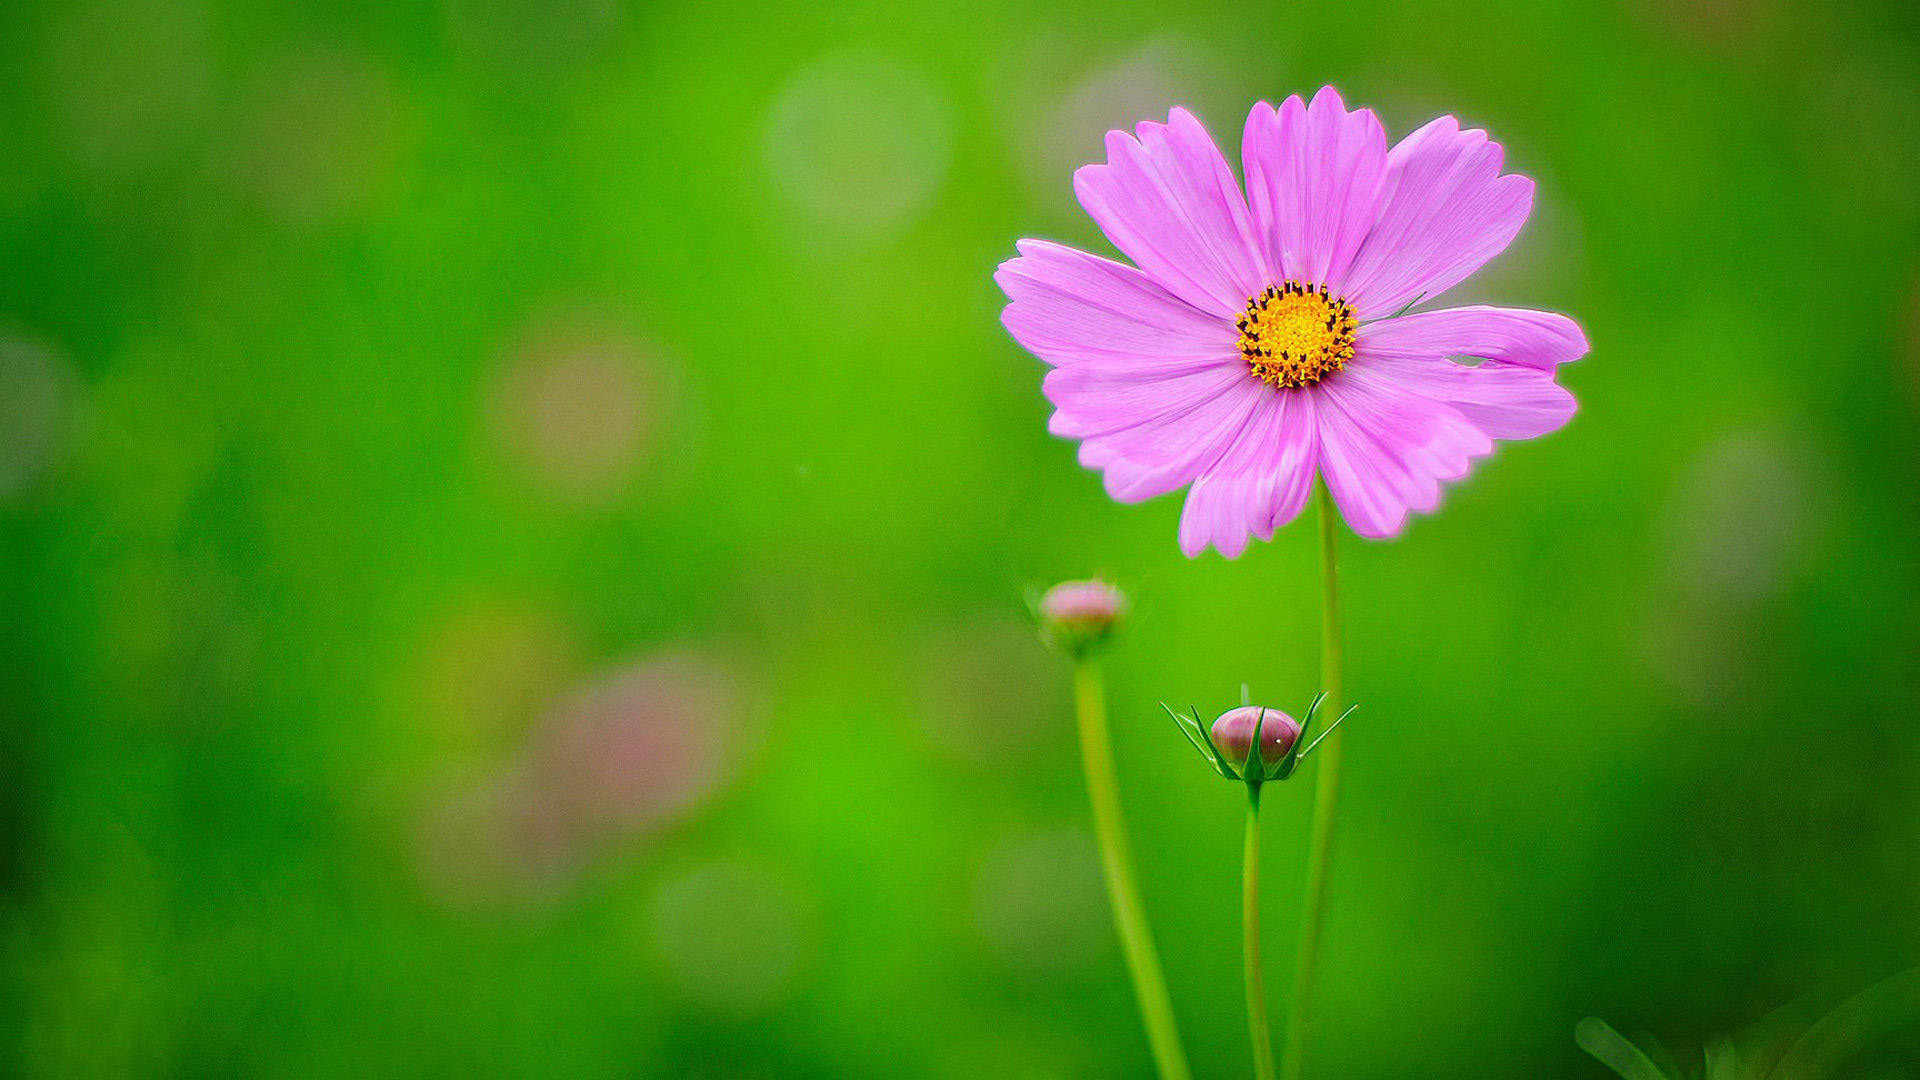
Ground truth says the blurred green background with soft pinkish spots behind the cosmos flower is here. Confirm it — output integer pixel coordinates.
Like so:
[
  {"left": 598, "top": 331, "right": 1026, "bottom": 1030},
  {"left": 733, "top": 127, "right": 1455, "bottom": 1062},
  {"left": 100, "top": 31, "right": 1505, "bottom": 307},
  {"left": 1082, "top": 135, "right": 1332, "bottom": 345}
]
[{"left": 0, "top": 0, "right": 1920, "bottom": 1078}]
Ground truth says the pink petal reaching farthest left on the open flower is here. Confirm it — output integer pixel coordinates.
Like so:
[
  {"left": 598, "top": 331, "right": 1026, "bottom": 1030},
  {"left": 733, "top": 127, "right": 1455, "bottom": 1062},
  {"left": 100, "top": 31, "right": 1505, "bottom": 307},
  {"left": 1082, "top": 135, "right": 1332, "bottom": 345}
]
[{"left": 993, "top": 240, "right": 1238, "bottom": 373}]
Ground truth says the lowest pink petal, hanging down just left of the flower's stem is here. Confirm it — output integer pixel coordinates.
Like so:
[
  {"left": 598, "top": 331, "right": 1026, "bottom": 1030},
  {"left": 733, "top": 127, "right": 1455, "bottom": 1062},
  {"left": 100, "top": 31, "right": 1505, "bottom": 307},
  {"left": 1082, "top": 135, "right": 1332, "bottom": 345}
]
[{"left": 1181, "top": 390, "right": 1315, "bottom": 559}]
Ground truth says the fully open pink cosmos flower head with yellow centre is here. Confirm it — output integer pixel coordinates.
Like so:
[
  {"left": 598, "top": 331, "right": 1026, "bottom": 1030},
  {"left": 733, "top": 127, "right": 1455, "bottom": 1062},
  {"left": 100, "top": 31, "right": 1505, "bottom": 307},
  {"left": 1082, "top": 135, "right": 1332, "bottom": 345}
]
[{"left": 995, "top": 86, "right": 1588, "bottom": 559}]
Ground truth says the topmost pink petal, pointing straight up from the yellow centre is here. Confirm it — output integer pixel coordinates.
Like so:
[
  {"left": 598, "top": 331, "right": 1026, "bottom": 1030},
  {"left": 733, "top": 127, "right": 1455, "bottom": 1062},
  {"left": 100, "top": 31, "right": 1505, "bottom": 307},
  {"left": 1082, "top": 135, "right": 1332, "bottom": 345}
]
[{"left": 1240, "top": 86, "right": 1386, "bottom": 292}]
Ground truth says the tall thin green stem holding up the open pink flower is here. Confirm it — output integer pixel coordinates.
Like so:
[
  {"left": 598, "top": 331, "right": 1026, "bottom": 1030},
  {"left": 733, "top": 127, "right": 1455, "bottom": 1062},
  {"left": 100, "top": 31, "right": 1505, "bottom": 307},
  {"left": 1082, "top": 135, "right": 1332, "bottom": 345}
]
[{"left": 1281, "top": 480, "right": 1346, "bottom": 1080}]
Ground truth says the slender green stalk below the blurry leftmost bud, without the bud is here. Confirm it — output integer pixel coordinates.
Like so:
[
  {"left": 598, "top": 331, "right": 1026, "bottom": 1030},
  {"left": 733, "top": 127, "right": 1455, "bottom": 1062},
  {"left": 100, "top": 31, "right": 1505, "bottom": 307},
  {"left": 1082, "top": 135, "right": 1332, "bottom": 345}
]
[{"left": 1073, "top": 655, "right": 1192, "bottom": 1080}]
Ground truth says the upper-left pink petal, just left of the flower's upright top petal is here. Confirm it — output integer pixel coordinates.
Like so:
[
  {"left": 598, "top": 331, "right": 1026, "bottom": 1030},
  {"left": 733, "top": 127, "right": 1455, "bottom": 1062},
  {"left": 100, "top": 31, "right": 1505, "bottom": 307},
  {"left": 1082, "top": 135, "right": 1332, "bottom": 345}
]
[{"left": 1073, "top": 110, "right": 1269, "bottom": 319}]
